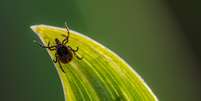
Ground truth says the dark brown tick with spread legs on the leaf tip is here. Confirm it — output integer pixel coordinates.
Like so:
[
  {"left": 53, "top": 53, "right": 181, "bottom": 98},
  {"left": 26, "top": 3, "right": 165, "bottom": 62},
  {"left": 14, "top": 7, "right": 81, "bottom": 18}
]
[{"left": 35, "top": 23, "right": 83, "bottom": 73}]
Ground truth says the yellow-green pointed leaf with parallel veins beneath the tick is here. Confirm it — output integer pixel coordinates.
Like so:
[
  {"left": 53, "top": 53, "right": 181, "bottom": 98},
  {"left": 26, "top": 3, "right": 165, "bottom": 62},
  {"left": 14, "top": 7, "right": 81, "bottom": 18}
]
[{"left": 31, "top": 25, "right": 157, "bottom": 101}]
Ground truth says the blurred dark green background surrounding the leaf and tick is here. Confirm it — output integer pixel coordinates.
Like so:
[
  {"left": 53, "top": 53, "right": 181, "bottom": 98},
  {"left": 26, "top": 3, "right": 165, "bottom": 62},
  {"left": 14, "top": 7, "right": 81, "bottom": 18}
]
[{"left": 0, "top": 0, "right": 201, "bottom": 101}]
